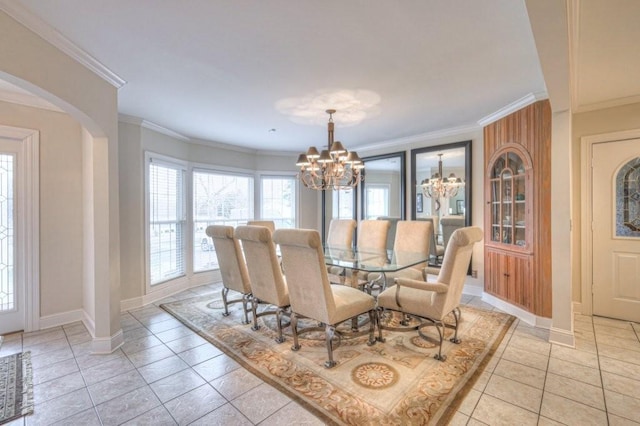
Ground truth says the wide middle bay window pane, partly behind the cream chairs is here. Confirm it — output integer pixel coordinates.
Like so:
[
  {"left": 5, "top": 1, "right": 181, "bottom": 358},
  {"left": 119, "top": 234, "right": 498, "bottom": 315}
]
[{"left": 193, "top": 171, "right": 253, "bottom": 272}]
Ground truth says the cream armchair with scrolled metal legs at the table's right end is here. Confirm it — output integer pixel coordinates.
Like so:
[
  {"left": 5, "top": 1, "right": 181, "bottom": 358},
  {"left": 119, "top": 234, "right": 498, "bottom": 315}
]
[{"left": 378, "top": 226, "right": 482, "bottom": 361}]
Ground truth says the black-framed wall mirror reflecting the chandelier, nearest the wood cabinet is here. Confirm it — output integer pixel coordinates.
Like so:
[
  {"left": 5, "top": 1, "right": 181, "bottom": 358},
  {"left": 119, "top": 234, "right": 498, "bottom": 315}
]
[{"left": 411, "top": 141, "right": 471, "bottom": 264}]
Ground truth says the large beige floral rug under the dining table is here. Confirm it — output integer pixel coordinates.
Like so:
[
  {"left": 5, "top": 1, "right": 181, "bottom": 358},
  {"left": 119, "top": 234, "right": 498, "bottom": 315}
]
[{"left": 161, "top": 296, "right": 514, "bottom": 425}]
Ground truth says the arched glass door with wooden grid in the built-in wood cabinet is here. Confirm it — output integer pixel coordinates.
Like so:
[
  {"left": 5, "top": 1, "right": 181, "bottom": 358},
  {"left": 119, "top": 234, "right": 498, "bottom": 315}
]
[{"left": 489, "top": 151, "right": 528, "bottom": 247}]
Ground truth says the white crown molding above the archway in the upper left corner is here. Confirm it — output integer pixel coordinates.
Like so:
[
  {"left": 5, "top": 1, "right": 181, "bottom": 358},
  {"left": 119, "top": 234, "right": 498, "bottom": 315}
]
[{"left": 0, "top": 0, "right": 127, "bottom": 89}]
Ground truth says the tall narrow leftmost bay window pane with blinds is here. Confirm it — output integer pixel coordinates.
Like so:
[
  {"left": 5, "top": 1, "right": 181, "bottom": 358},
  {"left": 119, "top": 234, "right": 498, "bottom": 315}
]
[{"left": 149, "top": 163, "right": 185, "bottom": 285}]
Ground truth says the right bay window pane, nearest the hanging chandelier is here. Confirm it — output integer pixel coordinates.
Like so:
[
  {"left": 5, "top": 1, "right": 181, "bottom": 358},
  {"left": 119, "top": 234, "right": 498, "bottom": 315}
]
[{"left": 260, "top": 176, "right": 296, "bottom": 228}]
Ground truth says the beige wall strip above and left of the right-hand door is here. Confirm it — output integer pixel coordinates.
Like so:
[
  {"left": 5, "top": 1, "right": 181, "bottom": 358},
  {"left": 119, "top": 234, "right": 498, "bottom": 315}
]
[{"left": 571, "top": 103, "right": 640, "bottom": 302}]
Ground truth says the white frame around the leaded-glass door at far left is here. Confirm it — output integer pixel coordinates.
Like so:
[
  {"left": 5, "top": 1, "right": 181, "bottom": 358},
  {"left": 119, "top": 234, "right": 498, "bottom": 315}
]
[{"left": 0, "top": 125, "right": 40, "bottom": 332}]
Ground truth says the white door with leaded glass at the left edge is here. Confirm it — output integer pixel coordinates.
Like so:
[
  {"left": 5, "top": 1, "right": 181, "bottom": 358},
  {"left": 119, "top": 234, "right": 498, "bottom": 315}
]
[{"left": 0, "top": 138, "right": 25, "bottom": 335}]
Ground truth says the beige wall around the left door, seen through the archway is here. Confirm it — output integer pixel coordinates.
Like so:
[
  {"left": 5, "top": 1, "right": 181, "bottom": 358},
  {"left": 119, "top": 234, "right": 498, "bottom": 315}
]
[{"left": 0, "top": 102, "right": 83, "bottom": 316}]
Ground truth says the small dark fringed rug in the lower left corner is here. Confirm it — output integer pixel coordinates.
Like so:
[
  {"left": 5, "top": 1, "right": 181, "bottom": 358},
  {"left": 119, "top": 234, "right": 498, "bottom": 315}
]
[{"left": 0, "top": 352, "right": 33, "bottom": 424}]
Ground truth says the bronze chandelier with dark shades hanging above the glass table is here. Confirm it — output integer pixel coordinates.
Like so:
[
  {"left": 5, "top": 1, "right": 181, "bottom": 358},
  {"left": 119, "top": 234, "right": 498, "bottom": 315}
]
[{"left": 296, "top": 109, "right": 364, "bottom": 191}]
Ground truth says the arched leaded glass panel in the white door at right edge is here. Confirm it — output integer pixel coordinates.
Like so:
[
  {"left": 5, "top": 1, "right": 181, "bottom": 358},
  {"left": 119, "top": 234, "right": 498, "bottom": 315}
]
[{"left": 616, "top": 157, "right": 640, "bottom": 237}]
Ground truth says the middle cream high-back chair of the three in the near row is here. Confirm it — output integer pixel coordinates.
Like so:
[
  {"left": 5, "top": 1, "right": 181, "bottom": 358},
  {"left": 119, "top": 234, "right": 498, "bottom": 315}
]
[{"left": 235, "top": 226, "right": 289, "bottom": 343}]
